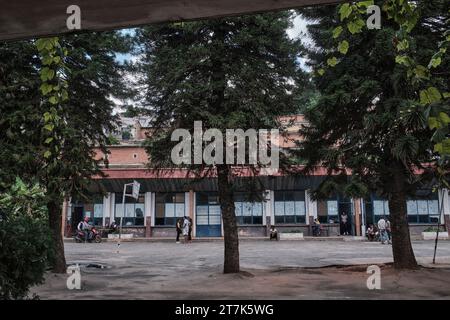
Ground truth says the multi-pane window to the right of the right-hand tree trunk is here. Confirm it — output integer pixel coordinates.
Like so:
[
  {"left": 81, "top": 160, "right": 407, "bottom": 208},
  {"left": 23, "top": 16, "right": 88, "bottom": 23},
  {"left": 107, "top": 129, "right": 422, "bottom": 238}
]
[{"left": 406, "top": 199, "right": 439, "bottom": 223}]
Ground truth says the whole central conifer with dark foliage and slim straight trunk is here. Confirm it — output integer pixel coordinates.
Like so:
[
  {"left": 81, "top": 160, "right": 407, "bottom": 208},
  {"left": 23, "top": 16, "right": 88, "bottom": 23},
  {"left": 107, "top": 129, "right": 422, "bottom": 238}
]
[{"left": 138, "top": 12, "right": 304, "bottom": 273}]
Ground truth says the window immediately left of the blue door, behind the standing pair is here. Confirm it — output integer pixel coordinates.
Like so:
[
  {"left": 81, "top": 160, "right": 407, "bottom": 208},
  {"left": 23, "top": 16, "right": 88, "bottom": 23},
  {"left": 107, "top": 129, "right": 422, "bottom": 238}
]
[{"left": 155, "top": 192, "right": 185, "bottom": 226}]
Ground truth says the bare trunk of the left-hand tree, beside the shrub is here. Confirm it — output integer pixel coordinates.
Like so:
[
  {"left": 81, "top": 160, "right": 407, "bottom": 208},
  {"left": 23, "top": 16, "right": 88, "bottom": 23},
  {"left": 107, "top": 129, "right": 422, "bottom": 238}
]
[{"left": 47, "top": 201, "right": 66, "bottom": 273}]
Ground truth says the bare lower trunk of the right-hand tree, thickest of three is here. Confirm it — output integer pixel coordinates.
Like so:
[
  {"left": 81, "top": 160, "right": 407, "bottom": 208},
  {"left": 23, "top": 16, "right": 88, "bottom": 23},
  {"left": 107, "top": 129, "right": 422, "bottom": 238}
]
[{"left": 389, "top": 163, "right": 418, "bottom": 269}]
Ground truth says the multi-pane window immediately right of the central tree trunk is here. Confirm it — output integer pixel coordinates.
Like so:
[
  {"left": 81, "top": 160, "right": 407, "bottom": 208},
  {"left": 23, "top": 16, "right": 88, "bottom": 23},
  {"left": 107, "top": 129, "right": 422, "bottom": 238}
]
[{"left": 234, "top": 193, "right": 264, "bottom": 225}]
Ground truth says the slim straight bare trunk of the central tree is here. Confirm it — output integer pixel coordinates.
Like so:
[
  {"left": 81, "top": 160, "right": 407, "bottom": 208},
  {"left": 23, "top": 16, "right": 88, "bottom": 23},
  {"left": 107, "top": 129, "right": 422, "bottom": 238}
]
[{"left": 217, "top": 165, "right": 239, "bottom": 273}]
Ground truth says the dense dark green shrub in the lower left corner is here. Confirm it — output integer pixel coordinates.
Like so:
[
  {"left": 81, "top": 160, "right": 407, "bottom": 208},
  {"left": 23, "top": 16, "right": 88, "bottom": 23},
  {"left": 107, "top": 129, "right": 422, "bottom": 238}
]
[{"left": 0, "top": 179, "right": 52, "bottom": 299}]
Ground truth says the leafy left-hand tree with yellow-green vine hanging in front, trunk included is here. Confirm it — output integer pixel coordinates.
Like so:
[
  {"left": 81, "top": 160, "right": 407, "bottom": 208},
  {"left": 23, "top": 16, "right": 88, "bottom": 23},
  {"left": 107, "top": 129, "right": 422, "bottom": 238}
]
[{"left": 0, "top": 32, "right": 133, "bottom": 272}]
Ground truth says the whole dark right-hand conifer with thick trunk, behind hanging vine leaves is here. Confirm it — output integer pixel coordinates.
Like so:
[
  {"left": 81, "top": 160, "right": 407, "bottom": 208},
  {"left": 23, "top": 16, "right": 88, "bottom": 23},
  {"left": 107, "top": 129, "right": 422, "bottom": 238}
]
[{"left": 299, "top": 0, "right": 448, "bottom": 268}]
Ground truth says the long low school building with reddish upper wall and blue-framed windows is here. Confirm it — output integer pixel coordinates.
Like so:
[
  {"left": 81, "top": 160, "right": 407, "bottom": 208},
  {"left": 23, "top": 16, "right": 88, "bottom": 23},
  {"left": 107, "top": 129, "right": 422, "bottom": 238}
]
[{"left": 63, "top": 115, "right": 450, "bottom": 238}]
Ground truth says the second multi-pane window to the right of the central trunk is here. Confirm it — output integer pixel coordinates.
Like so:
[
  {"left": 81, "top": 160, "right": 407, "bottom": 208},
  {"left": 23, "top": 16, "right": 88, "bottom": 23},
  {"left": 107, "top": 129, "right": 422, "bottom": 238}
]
[{"left": 274, "top": 191, "right": 306, "bottom": 223}]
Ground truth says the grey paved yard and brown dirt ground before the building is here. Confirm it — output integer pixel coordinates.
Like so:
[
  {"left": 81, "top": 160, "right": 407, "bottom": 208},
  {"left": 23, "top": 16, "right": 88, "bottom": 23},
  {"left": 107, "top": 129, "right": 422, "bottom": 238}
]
[{"left": 31, "top": 241, "right": 450, "bottom": 299}]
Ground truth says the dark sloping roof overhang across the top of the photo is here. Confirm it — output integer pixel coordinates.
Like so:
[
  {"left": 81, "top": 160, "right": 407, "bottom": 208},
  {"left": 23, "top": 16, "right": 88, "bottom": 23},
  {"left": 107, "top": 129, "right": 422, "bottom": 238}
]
[{"left": 0, "top": 0, "right": 345, "bottom": 40}]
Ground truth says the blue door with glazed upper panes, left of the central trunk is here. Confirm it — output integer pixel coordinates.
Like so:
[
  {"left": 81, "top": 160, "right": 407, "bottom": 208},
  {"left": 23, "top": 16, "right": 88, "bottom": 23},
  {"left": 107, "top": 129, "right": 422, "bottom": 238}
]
[{"left": 195, "top": 192, "right": 222, "bottom": 237}]
